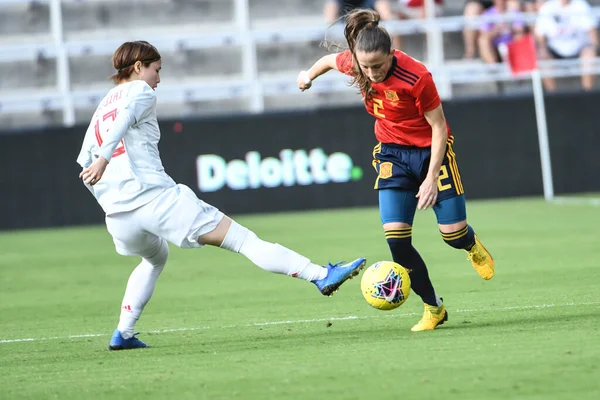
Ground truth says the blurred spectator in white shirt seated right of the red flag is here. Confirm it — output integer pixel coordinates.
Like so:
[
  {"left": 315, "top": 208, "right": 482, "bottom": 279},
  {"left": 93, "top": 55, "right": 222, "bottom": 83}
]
[{"left": 535, "top": 0, "right": 598, "bottom": 91}]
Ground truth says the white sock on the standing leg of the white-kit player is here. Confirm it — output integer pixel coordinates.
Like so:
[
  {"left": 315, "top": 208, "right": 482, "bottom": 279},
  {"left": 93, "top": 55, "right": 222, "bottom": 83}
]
[{"left": 117, "top": 240, "right": 169, "bottom": 339}]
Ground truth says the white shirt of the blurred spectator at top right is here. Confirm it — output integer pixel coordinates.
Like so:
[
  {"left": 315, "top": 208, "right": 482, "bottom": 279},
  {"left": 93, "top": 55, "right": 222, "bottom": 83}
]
[{"left": 535, "top": 0, "right": 596, "bottom": 57}]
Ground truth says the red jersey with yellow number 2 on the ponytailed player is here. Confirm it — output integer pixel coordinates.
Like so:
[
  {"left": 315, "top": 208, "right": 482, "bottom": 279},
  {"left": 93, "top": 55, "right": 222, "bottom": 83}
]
[{"left": 336, "top": 50, "right": 451, "bottom": 147}]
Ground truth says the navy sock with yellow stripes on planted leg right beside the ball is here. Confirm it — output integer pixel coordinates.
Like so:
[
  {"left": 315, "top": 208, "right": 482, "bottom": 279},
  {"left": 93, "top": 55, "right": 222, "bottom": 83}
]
[{"left": 385, "top": 228, "right": 438, "bottom": 306}]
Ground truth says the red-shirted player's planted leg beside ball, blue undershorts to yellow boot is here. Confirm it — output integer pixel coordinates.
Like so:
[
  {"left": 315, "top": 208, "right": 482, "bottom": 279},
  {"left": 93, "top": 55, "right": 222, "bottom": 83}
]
[{"left": 379, "top": 188, "right": 448, "bottom": 331}]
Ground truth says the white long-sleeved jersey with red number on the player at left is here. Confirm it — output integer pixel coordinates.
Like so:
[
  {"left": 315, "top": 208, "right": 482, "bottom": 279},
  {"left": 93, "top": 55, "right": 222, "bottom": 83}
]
[{"left": 77, "top": 80, "right": 176, "bottom": 215}]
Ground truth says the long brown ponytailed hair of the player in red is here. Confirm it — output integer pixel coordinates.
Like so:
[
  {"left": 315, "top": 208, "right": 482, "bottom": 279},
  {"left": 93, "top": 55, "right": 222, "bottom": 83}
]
[{"left": 344, "top": 8, "right": 392, "bottom": 99}]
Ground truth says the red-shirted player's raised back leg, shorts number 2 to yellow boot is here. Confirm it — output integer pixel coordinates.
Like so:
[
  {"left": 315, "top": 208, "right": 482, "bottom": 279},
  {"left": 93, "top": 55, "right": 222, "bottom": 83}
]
[{"left": 433, "top": 137, "right": 494, "bottom": 280}]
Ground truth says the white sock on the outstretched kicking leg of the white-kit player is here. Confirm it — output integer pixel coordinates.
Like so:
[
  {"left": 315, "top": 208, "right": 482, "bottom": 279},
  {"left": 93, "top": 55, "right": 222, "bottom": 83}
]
[{"left": 221, "top": 221, "right": 327, "bottom": 281}]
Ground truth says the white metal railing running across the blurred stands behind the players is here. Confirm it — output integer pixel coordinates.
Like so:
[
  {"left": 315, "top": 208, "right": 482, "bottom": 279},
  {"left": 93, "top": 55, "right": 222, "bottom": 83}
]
[{"left": 0, "top": 0, "right": 600, "bottom": 126}]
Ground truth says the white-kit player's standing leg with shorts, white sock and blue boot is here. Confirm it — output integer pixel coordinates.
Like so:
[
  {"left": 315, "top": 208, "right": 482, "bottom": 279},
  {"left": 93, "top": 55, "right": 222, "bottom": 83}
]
[{"left": 106, "top": 211, "right": 169, "bottom": 350}]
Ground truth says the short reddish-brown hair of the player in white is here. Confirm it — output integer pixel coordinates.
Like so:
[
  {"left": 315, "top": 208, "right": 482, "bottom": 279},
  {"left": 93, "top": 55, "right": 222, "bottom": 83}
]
[{"left": 110, "top": 40, "right": 160, "bottom": 83}]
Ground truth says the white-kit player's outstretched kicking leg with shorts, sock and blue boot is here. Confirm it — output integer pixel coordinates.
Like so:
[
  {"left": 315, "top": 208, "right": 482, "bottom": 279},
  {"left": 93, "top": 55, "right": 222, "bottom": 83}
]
[{"left": 150, "top": 185, "right": 366, "bottom": 296}]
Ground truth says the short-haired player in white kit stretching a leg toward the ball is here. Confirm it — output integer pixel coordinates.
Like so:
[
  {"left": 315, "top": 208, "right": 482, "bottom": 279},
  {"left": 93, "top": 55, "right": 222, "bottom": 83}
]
[{"left": 77, "top": 41, "right": 366, "bottom": 350}]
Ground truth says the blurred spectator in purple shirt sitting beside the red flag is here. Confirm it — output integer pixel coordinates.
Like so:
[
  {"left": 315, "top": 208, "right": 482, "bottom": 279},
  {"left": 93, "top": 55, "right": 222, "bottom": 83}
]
[{"left": 478, "top": 0, "right": 526, "bottom": 64}]
